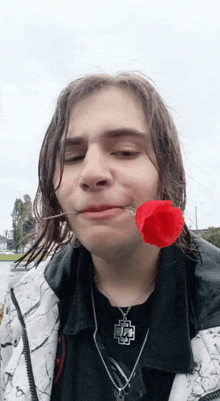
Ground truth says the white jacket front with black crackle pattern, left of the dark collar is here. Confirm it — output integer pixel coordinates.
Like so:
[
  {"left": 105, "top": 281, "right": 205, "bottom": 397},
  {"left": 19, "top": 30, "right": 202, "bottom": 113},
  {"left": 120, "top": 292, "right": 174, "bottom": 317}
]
[{"left": 0, "top": 266, "right": 59, "bottom": 401}]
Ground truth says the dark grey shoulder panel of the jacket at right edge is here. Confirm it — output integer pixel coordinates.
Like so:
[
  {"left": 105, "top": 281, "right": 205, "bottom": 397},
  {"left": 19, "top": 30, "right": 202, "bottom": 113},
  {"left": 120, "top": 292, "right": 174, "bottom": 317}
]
[{"left": 191, "top": 236, "right": 220, "bottom": 330}]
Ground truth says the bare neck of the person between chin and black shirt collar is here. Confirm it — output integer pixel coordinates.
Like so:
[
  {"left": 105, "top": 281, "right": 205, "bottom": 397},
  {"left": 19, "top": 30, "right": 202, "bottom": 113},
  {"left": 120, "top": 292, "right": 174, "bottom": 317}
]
[{"left": 92, "top": 244, "right": 160, "bottom": 307}]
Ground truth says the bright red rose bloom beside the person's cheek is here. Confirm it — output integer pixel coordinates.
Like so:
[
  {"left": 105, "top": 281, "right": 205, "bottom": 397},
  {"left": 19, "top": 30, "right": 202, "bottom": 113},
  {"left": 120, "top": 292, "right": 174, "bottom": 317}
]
[{"left": 135, "top": 200, "right": 184, "bottom": 248}]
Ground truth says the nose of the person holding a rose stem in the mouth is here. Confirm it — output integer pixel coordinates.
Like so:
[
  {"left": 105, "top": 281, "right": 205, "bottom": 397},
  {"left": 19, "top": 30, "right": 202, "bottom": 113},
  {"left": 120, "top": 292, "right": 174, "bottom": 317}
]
[{"left": 79, "top": 146, "right": 112, "bottom": 192}]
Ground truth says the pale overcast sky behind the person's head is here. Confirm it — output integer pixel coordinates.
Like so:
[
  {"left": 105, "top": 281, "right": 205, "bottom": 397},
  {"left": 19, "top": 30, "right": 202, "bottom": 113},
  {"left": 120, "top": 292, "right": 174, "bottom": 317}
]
[{"left": 0, "top": 0, "right": 220, "bottom": 234}]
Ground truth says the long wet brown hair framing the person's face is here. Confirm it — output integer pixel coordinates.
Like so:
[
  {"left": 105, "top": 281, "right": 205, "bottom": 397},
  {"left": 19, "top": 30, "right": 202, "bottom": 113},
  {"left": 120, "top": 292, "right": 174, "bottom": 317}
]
[{"left": 21, "top": 72, "right": 195, "bottom": 263}]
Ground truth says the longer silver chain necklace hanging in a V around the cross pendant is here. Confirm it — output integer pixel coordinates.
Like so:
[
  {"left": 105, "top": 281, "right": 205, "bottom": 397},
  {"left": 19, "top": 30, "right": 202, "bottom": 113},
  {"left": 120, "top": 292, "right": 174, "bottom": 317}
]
[{"left": 91, "top": 287, "right": 149, "bottom": 401}]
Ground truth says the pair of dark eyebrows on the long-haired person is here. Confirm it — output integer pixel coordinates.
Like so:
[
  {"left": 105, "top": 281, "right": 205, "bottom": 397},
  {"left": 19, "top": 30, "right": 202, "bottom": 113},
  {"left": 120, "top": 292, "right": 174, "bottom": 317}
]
[{"left": 62, "top": 128, "right": 149, "bottom": 148}]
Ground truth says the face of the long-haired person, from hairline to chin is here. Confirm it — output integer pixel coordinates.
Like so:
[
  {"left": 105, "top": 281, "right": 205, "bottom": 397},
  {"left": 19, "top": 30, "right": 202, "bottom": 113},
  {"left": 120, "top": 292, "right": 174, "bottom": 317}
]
[{"left": 54, "top": 87, "right": 159, "bottom": 255}]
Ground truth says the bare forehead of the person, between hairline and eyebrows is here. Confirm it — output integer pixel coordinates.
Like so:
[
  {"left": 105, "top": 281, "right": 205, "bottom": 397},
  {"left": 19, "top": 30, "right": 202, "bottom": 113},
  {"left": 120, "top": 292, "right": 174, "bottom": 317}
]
[{"left": 64, "top": 87, "right": 147, "bottom": 143}]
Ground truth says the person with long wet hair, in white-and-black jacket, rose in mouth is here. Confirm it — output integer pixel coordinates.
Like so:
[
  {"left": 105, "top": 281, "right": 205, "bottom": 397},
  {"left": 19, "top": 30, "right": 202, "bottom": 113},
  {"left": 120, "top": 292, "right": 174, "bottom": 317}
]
[{"left": 0, "top": 72, "right": 220, "bottom": 401}]
